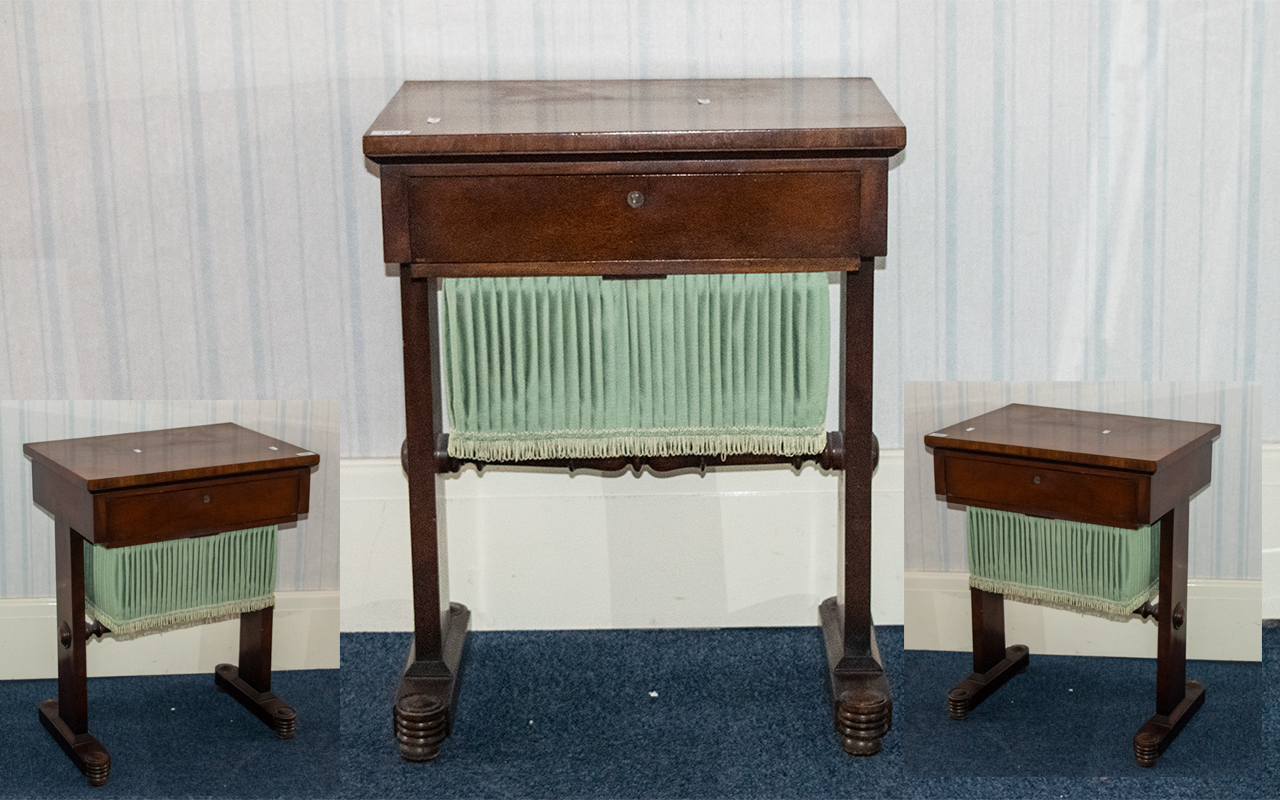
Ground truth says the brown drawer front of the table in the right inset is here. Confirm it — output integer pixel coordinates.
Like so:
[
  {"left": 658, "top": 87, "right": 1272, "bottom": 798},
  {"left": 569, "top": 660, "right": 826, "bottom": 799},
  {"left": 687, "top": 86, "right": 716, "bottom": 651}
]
[{"left": 934, "top": 452, "right": 1140, "bottom": 527}]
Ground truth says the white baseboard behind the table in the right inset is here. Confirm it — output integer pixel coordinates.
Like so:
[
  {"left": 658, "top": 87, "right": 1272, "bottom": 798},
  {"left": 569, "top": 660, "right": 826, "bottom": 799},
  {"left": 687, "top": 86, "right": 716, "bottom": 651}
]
[{"left": 905, "top": 571, "right": 1262, "bottom": 660}]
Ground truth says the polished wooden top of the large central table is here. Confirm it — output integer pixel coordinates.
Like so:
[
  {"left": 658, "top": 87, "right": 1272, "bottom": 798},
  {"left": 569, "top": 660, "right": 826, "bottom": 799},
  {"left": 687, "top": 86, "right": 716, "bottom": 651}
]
[{"left": 364, "top": 78, "right": 906, "bottom": 161}]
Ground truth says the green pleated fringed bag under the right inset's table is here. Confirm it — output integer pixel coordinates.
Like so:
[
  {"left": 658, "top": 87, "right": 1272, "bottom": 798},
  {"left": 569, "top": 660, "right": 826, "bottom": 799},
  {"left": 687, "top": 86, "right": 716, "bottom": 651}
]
[{"left": 965, "top": 506, "right": 1160, "bottom": 620}]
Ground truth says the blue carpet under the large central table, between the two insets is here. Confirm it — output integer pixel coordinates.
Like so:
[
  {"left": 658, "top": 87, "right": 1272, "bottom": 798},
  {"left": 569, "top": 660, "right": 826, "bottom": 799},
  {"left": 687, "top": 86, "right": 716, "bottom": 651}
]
[{"left": 342, "top": 627, "right": 902, "bottom": 799}]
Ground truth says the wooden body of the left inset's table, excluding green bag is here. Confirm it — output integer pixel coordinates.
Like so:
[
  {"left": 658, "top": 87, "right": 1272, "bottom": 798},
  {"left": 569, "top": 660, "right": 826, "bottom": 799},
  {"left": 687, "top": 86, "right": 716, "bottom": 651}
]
[{"left": 22, "top": 422, "right": 320, "bottom": 786}]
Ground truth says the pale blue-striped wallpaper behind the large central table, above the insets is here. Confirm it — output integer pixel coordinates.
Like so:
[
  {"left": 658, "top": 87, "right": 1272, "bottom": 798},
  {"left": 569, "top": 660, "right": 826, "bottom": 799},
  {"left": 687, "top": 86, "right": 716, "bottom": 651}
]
[{"left": 0, "top": 0, "right": 1280, "bottom": 456}]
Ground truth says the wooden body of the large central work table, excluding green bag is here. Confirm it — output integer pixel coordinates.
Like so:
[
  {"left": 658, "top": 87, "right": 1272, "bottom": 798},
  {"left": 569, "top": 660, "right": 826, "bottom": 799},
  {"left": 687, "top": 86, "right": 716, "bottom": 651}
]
[{"left": 364, "top": 78, "right": 906, "bottom": 760}]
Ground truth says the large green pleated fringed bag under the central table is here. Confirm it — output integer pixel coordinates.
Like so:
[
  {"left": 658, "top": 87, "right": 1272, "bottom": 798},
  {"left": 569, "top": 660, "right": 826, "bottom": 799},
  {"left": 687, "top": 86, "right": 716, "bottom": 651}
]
[{"left": 443, "top": 273, "right": 831, "bottom": 461}]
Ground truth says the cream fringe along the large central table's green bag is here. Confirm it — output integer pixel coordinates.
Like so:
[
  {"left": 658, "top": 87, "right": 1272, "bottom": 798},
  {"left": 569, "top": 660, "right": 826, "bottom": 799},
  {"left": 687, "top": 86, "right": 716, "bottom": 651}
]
[{"left": 449, "top": 430, "right": 827, "bottom": 462}]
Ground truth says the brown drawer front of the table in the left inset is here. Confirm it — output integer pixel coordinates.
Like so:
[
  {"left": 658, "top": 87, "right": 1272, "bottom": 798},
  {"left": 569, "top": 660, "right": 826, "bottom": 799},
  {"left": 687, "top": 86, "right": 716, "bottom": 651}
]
[{"left": 95, "top": 472, "right": 301, "bottom": 544}]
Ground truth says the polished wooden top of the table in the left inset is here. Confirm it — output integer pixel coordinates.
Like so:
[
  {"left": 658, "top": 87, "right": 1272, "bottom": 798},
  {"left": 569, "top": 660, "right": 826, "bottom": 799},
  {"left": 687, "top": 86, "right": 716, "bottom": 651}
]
[{"left": 22, "top": 422, "right": 320, "bottom": 492}]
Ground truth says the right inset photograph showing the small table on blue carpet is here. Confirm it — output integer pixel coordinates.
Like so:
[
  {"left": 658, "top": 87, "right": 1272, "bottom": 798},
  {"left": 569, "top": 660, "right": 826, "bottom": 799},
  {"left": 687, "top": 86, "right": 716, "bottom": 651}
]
[{"left": 905, "top": 383, "right": 1261, "bottom": 776}]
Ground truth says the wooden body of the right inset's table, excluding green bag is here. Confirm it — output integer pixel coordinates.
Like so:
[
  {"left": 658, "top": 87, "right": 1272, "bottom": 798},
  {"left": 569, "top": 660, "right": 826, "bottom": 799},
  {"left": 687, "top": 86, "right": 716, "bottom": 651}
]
[{"left": 924, "top": 404, "right": 1222, "bottom": 767}]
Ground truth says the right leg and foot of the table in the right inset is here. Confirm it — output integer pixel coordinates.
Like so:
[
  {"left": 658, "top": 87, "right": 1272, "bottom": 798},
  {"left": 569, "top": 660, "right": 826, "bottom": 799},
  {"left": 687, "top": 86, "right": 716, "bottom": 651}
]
[{"left": 1133, "top": 498, "right": 1204, "bottom": 767}]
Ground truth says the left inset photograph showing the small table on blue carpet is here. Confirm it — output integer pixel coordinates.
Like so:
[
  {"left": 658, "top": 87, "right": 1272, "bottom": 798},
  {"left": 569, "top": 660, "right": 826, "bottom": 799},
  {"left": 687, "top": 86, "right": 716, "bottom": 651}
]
[{"left": 0, "top": 402, "right": 338, "bottom": 796}]
